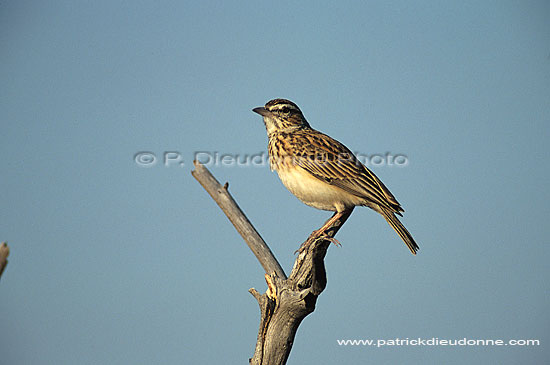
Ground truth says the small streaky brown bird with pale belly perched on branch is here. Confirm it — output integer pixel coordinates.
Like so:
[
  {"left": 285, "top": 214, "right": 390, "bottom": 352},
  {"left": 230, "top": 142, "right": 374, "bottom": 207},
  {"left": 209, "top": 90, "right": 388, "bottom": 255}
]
[{"left": 252, "top": 99, "right": 419, "bottom": 255}]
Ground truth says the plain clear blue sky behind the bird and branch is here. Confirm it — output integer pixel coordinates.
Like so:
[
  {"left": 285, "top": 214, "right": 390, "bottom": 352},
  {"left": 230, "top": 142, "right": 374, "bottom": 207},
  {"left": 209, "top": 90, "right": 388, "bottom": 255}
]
[{"left": 0, "top": 1, "right": 550, "bottom": 364}]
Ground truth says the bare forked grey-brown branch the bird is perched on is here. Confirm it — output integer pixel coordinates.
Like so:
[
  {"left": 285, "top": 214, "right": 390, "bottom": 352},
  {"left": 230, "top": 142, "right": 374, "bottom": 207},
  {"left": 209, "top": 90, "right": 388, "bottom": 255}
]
[{"left": 191, "top": 162, "right": 353, "bottom": 365}]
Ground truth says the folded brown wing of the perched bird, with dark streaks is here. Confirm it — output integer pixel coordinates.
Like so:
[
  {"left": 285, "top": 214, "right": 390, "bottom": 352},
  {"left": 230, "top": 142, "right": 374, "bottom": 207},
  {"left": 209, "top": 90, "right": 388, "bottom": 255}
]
[{"left": 292, "top": 129, "right": 403, "bottom": 214}]
